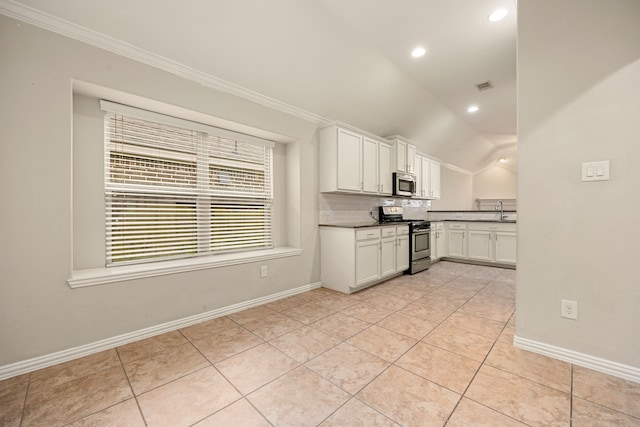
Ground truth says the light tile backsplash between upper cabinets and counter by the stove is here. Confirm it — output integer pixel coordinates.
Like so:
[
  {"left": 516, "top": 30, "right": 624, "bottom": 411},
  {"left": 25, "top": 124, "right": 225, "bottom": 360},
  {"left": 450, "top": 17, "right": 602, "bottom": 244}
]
[{"left": 318, "top": 193, "right": 431, "bottom": 224}]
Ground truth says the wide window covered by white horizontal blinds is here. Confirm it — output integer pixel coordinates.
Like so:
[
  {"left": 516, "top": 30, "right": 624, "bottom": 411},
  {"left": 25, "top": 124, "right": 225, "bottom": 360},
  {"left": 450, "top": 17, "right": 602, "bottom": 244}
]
[{"left": 101, "top": 101, "right": 273, "bottom": 266}]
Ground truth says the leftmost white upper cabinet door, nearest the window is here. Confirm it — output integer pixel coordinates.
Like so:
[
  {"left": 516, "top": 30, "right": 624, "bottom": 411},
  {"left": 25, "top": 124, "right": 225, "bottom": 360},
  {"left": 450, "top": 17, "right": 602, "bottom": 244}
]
[{"left": 337, "top": 129, "right": 362, "bottom": 192}]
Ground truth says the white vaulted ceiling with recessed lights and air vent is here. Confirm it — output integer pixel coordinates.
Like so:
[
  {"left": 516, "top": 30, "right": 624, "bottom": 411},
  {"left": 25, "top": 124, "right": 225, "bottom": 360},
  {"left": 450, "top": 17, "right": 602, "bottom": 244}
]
[{"left": 3, "top": 0, "right": 517, "bottom": 172}]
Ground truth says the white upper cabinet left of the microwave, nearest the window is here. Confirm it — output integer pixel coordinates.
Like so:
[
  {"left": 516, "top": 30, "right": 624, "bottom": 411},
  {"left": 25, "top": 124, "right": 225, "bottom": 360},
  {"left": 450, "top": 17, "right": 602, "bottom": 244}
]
[{"left": 320, "top": 125, "right": 391, "bottom": 195}]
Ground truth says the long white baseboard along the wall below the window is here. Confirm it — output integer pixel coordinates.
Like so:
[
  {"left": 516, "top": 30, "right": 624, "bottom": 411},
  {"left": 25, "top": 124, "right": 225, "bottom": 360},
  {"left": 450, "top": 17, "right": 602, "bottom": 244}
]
[{"left": 0, "top": 282, "right": 322, "bottom": 380}]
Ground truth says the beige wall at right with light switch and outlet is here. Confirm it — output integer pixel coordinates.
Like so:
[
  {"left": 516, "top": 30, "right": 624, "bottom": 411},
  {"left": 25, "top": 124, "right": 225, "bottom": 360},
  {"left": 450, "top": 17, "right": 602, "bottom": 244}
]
[{"left": 516, "top": 0, "right": 640, "bottom": 370}]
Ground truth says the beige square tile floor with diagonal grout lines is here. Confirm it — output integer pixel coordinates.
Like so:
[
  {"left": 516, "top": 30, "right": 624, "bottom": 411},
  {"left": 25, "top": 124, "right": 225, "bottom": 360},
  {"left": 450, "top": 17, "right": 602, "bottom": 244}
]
[{"left": 0, "top": 262, "right": 640, "bottom": 427}]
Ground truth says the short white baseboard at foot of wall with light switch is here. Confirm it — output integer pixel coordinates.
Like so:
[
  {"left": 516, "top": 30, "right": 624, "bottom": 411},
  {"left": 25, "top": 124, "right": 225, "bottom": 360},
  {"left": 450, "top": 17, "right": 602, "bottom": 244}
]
[{"left": 513, "top": 335, "right": 640, "bottom": 383}]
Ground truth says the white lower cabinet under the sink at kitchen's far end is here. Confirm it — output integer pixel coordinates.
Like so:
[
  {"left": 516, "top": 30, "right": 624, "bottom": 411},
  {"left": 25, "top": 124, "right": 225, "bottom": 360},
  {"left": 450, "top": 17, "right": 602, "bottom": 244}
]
[{"left": 446, "top": 222, "right": 517, "bottom": 265}]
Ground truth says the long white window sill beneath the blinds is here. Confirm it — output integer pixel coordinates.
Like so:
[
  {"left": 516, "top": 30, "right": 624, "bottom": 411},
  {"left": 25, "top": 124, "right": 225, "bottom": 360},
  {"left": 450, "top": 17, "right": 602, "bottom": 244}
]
[{"left": 67, "top": 247, "right": 302, "bottom": 288}]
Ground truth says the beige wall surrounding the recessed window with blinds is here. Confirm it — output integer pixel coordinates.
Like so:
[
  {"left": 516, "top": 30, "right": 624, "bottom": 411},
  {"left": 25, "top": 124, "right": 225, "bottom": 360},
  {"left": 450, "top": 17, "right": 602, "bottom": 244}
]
[{"left": 0, "top": 15, "right": 320, "bottom": 366}]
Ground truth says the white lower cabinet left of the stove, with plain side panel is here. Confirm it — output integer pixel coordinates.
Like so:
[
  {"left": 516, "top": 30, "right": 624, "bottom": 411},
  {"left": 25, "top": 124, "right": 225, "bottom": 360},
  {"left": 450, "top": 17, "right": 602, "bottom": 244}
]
[{"left": 320, "top": 225, "right": 409, "bottom": 293}]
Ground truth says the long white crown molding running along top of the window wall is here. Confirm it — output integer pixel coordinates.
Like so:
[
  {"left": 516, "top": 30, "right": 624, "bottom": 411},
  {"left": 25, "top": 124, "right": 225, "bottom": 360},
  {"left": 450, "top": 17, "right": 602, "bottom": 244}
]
[{"left": 0, "top": 0, "right": 331, "bottom": 125}]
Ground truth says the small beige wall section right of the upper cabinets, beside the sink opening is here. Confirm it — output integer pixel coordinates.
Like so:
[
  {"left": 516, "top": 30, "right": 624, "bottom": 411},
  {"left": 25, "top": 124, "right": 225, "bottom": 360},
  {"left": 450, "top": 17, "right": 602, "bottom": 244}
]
[{"left": 431, "top": 166, "right": 473, "bottom": 211}]
